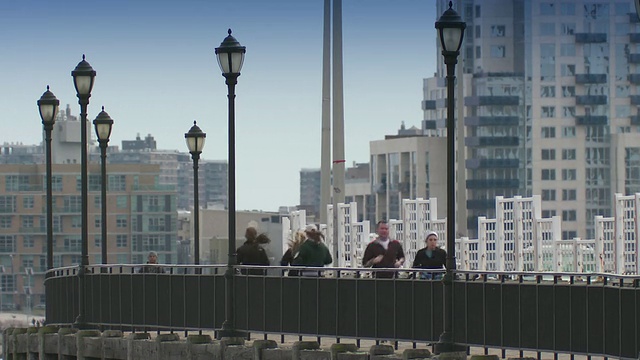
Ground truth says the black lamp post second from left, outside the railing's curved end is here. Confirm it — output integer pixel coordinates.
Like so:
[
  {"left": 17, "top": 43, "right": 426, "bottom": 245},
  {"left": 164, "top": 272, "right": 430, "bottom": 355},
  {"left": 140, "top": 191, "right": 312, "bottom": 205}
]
[{"left": 71, "top": 55, "right": 96, "bottom": 328}]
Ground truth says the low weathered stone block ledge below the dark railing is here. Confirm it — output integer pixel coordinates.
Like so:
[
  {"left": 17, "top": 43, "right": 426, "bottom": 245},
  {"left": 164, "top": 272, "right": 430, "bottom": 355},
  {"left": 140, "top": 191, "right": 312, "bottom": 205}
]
[{"left": 2, "top": 326, "right": 467, "bottom": 360}]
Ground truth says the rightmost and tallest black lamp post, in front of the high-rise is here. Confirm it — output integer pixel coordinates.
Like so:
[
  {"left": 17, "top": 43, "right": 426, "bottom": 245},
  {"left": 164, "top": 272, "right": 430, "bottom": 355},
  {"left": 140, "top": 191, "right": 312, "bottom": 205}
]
[{"left": 435, "top": 1, "right": 467, "bottom": 354}]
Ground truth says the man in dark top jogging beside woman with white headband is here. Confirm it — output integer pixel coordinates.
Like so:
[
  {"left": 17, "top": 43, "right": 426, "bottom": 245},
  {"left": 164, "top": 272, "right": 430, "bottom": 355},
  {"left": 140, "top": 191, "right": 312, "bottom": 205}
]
[{"left": 362, "top": 220, "right": 404, "bottom": 278}]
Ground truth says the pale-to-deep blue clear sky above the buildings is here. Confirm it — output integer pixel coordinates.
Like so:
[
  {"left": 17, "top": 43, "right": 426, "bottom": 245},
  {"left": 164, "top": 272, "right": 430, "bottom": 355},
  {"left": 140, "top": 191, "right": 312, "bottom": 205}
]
[{"left": 0, "top": 0, "right": 437, "bottom": 210}]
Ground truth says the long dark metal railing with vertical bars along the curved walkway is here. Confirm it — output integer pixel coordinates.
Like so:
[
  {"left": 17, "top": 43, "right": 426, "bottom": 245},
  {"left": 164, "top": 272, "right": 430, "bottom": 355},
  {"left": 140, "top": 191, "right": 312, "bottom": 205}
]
[{"left": 45, "top": 265, "right": 640, "bottom": 358}]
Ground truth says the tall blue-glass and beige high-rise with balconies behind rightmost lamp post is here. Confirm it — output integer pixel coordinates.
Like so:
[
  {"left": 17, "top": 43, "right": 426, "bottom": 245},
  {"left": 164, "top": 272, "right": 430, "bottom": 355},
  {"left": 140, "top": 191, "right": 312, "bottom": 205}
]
[{"left": 422, "top": 0, "right": 640, "bottom": 239}]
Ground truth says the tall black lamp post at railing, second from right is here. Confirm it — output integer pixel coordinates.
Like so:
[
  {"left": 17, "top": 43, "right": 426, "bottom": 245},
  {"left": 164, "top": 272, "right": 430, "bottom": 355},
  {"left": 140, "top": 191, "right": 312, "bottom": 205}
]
[{"left": 216, "top": 29, "right": 246, "bottom": 338}]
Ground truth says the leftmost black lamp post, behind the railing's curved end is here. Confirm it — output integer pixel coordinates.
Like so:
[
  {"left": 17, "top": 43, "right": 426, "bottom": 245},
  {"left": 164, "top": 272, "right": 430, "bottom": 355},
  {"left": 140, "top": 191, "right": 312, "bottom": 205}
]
[{"left": 38, "top": 85, "right": 60, "bottom": 270}]
